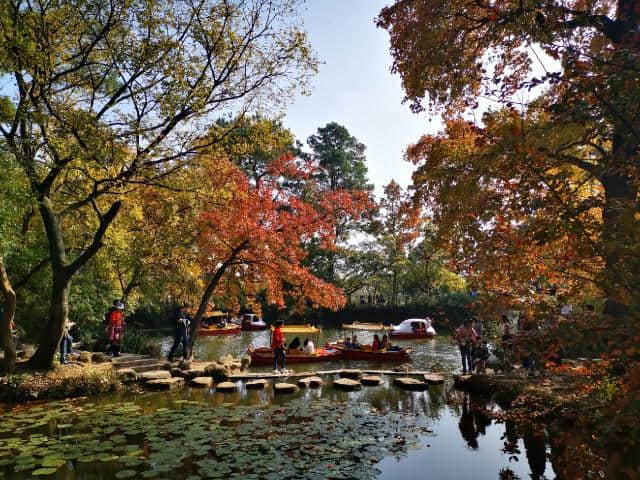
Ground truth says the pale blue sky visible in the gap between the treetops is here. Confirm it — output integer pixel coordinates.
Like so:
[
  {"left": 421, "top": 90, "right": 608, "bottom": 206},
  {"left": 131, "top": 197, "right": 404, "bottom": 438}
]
[{"left": 283, "top": 0, "right": 440, "bottom": 195}]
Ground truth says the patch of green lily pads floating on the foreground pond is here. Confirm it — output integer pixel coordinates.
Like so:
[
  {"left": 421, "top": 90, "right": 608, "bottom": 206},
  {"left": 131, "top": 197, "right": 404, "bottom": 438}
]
[{"left": 0, "top": 400, "right": 427, "bottom": 480}]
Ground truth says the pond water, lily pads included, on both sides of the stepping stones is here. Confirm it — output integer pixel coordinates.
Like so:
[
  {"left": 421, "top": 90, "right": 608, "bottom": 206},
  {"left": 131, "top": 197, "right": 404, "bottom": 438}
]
[{"left": 0, "top": 331, "right": 555, "bottom": 480}]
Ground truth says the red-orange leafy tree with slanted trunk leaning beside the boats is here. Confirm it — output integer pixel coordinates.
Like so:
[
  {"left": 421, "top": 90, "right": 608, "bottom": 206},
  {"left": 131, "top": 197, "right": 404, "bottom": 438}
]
[{"left": 188, "top": 156, "right": 363, "bottom": 352}]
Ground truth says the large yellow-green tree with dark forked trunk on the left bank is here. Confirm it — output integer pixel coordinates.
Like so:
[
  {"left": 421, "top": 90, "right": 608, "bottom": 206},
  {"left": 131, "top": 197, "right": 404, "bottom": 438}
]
[{"left": 0, "top": 0, "right": 316, "bottom": 368}]
